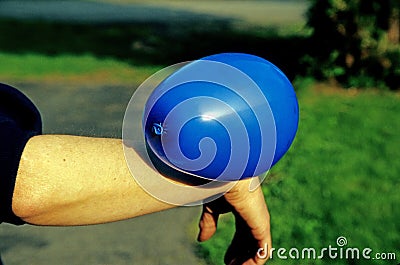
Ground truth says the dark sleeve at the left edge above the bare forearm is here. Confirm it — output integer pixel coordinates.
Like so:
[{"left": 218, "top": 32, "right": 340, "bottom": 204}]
[{"left": 0, "top": 83, "right": 42, "bottom": 225}]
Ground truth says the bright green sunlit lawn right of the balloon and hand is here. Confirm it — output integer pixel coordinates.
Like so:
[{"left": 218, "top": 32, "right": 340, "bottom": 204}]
[{"left": 198, "top": 80, "right": 400, "bottom": 265}]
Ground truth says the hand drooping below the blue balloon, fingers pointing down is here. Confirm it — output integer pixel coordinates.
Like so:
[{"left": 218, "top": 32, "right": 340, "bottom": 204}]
[{"left": 198, "top": 179, "right": 272, "bottom": 265}]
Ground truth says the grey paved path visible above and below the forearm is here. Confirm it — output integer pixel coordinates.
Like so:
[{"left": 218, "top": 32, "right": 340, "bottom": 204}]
[{"left": 0, "top": 84, "right": 204, "bottom": 265}]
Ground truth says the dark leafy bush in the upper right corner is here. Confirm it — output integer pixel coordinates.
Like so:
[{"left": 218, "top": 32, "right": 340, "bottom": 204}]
[{"left": 301, "top": 0, "right": 400, "bottom": 90}]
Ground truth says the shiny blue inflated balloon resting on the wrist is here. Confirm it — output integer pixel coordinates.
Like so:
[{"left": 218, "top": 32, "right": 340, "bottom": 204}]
[{"left": 142, "top": 53, "right": 299, "bottom": 181}]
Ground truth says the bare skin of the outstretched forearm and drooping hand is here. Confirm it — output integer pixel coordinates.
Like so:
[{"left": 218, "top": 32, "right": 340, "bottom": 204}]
[{"left": 12, "top": 135, "right": 271, "bottom": 264}]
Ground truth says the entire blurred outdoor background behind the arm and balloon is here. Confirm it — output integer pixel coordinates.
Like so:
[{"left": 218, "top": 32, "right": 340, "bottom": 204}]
[{"left": 0, "top": 0, "right": 400, "bottom": 265}]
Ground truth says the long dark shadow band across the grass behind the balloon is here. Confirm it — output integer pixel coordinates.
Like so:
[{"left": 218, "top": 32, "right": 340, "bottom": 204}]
[{"left": 0, "top": 17, "right": 308, "bottom": 79}]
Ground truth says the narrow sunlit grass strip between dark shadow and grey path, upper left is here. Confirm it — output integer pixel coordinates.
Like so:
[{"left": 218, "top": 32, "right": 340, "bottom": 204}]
[{"left": 0, "top": 53, "right": 160, "bottom": 84}]
